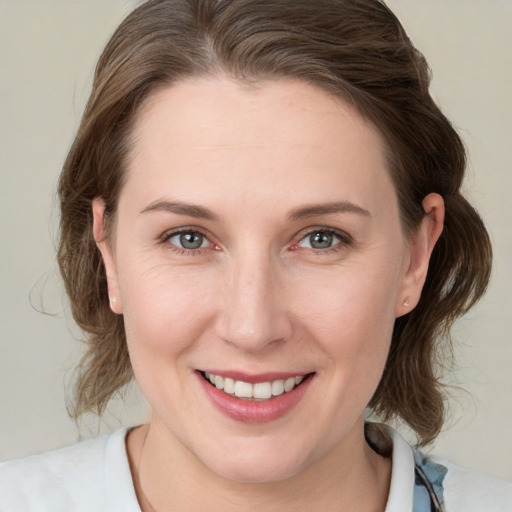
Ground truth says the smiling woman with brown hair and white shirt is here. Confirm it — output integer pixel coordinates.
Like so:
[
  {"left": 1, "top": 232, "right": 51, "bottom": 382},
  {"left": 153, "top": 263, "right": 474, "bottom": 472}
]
[{"left": 0, "top": 0, "right": 512, "bottom": 512}]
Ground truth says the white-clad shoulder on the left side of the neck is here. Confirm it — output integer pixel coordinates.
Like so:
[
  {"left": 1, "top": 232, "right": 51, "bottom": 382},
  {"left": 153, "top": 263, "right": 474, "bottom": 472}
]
[{"left": 0, "top": 429, "right": 140, "bottom": 512}]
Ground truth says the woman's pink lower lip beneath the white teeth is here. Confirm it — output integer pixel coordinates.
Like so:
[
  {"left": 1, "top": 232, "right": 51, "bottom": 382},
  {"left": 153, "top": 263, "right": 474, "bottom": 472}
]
[{"left": 197, "top": 372, "right": 313, "bottom": 423}]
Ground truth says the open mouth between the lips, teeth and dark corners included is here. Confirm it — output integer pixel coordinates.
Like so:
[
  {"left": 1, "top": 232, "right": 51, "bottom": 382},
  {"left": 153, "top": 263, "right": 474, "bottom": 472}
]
[{"left": 199, "top": 371, "right": 314, "bottom": 401}]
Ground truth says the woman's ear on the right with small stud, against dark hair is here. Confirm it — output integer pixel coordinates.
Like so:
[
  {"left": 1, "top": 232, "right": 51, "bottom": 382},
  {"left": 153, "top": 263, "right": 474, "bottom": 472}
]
[{"left": 395, "top": 193, "right": 444, "bottom": 317}]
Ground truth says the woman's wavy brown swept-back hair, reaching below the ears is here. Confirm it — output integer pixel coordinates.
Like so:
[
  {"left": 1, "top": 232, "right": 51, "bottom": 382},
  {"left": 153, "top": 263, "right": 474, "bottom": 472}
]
[{"left": 58, "top": 0, "right": 491, "bottom": 444}]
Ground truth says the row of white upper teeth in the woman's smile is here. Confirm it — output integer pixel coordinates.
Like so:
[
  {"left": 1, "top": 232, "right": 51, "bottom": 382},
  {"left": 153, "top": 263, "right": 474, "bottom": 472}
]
[{"left": 205, "top": 372, "right": 304, "bottom": 399}]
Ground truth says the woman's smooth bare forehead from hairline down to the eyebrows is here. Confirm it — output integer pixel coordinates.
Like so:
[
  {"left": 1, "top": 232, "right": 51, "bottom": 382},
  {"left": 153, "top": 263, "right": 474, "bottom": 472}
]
[{"left": 127, "top": 78, "right": 394, "bottom": 217}]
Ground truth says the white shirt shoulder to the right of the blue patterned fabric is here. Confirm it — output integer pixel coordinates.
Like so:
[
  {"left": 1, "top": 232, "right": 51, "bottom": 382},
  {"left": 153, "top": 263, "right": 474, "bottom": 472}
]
[{"left": 429, "top": 456, "right": 512, "bottom": 512}]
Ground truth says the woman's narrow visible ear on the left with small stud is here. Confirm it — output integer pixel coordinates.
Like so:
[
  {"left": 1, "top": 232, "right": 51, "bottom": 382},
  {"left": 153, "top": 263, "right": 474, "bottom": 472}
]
[{"left": 92, "top": 197, "right": 123, "bottom": 315}]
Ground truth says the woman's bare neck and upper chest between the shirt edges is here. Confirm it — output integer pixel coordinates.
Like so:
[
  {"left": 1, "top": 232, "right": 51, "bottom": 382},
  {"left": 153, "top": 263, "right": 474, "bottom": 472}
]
[{"left": 127, "top": 424, "right": 391, "bottom": 512}]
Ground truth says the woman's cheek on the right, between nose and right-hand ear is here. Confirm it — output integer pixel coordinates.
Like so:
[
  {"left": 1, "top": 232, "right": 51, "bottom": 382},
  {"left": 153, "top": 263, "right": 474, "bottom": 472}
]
[{"left": 293, "top": 262, "right": 400, "bottom": 382}]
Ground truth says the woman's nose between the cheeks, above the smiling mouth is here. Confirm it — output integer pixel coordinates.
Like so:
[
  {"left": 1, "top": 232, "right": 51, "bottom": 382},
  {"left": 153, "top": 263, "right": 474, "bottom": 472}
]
[{"left": 218, "top": 253, "right": 292, "bottom": 352}]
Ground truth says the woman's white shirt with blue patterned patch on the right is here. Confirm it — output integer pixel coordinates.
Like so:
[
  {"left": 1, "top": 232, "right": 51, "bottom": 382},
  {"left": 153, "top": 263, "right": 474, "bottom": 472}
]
[{"left": 0, "top": 428, "right": 512, "bottom": 512}]
